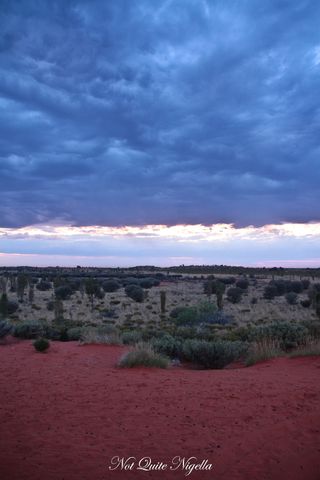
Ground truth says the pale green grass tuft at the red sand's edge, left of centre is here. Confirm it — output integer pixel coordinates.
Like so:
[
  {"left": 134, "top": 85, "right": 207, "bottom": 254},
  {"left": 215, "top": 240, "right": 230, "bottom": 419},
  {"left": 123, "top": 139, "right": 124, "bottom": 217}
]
[{"left": 119, "top": 342, "right": 169, "bottom": 368}]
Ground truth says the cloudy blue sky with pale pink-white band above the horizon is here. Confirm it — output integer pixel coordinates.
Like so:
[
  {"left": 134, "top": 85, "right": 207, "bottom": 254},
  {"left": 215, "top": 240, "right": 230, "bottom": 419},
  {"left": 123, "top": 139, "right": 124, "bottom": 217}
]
[{"left": 0, "top": 0, "right": 320, "bottom": 266}]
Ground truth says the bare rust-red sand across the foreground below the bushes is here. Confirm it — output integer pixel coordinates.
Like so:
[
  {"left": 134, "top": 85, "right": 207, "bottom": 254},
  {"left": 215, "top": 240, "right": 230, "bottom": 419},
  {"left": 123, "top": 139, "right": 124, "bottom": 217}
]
[{"left": 0, "top": 341, "right": 320, "bottom": 480}]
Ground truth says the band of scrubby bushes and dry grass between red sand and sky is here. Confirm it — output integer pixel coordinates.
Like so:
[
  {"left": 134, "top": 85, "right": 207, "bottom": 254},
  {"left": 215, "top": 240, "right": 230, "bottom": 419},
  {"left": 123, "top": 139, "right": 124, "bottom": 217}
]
[{"left": 0, "top": 266, "right": 320, "bottom": 368}]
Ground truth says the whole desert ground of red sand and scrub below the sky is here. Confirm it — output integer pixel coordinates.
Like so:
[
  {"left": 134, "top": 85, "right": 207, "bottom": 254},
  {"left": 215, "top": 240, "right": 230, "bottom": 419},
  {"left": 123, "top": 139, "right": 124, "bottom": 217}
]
[{"left": 0, "top": 268, "right": 320, "bottom": 480}]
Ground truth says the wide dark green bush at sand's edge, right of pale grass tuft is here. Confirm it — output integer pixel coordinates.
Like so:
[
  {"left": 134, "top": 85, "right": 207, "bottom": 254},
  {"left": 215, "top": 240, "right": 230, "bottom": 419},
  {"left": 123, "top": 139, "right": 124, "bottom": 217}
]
[{"left": 182, "top": 340, "right": 248, "bottom": 368}]
